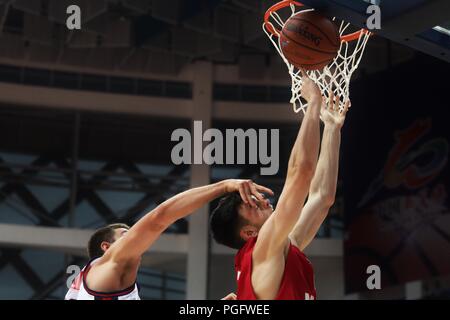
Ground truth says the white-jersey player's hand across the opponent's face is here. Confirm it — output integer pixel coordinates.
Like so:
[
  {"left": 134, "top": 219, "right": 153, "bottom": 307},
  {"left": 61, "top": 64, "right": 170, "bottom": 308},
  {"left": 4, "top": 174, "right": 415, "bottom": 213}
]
[{"left": 226, "top": 179, "right": 274, "bottom": 208}]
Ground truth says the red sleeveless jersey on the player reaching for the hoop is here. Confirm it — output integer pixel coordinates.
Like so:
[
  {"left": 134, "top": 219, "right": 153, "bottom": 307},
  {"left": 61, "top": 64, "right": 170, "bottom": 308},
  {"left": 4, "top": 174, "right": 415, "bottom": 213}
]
[{"left": 235, "top": 237, "right": 316, "bottom": 300}]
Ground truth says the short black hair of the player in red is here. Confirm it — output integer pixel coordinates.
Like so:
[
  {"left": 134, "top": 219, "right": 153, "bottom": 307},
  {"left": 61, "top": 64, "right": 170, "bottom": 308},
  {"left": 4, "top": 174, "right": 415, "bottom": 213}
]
[{"left": 209, "top": 192, "right": 248, "bottom": 249}]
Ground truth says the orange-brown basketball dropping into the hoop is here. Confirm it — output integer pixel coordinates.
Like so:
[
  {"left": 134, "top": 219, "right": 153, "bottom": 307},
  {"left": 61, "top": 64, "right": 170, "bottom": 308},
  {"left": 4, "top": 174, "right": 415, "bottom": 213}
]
[{"left": 279, "top": 11, "right": 340, "bottom": 70}]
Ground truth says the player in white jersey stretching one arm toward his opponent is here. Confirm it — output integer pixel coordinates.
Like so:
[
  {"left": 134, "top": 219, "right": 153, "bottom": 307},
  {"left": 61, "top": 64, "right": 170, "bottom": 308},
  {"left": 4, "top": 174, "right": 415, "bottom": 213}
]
[{"left": 65, "top": 179, "right": 273, "bottom": 300}]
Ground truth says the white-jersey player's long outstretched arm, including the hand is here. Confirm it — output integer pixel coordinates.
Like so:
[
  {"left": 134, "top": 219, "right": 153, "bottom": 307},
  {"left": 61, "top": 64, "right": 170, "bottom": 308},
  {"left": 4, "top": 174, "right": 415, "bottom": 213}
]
[{"left": 102, "top": 179, "right": 272, "bottom": 263}]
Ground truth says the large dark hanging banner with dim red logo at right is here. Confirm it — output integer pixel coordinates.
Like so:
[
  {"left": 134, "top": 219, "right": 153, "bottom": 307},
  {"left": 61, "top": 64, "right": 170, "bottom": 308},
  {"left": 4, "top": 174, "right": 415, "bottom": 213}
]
[{"left": 343, "top": 58, "right": 450, "bottom": 293}]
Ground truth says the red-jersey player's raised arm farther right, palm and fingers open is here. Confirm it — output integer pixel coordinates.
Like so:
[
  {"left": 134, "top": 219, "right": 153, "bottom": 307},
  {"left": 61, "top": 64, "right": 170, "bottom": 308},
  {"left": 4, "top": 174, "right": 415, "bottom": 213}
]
[{"left": 289, "top": 94, "right": 350, "bottom": 250}]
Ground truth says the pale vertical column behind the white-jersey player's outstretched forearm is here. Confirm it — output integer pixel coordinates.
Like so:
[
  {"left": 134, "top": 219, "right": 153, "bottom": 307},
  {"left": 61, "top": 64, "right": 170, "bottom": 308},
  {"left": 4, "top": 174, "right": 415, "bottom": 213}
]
[{"left": 186, "top": 62, "right": 213, "bottom": 300}]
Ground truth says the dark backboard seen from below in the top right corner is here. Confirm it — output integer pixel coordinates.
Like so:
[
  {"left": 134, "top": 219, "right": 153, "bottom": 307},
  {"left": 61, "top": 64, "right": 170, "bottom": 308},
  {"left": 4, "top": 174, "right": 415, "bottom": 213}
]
[{"left": 300, "top": 0, "right": 450, "bottom": 62}]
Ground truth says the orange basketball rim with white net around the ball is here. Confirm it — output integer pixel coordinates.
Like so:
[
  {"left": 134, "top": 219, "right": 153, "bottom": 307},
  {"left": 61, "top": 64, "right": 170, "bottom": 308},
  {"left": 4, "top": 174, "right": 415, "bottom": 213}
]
[{"left": 263, "top": 0, "right": 371, "bottom": 113}]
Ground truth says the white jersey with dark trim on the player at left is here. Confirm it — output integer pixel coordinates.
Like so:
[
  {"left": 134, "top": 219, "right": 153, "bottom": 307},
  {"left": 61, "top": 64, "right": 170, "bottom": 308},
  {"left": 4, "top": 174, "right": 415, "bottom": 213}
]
[{"left": 64, "top": 259, "right": 141, "bottom": 300}]
